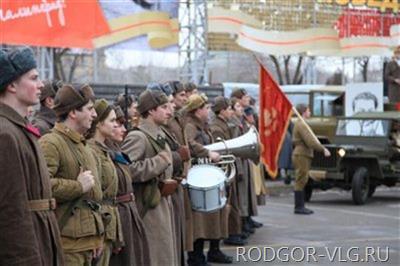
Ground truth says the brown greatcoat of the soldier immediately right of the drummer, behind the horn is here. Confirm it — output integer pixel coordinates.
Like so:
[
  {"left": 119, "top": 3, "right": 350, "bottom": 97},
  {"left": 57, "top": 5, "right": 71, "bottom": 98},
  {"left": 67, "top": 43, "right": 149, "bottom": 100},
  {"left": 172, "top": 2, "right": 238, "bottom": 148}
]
[{"left": 210, "top": 116, "right": 242, "bottom": 235}]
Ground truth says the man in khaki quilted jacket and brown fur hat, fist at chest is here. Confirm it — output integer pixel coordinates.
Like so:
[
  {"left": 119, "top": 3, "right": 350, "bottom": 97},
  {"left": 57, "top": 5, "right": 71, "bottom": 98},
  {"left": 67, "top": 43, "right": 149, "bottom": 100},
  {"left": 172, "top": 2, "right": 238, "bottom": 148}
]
[{"left": 40, "top": 85, "right": 104, "bottom": 266}]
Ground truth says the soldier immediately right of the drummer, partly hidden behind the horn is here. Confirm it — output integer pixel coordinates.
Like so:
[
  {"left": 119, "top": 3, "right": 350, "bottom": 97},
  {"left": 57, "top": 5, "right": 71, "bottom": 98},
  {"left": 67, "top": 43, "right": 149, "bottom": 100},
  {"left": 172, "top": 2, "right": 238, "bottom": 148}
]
[{"left": 210, "top": 96, "right": 247, "bottom": 246}]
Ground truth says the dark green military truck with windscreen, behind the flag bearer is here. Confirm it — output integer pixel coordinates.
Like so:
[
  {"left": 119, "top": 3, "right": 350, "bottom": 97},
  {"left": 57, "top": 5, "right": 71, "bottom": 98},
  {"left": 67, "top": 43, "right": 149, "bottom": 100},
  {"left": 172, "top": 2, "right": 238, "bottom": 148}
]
[{"left": 305, "top": 111, "right": 400, "bottom": 205}]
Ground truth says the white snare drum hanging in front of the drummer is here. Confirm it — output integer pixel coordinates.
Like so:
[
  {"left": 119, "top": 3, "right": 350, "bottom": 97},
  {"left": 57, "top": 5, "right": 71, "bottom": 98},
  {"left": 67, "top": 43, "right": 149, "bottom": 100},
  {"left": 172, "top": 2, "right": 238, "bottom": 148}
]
[{"left": 186, "top": 164, "right": 227, "bottom": 212}]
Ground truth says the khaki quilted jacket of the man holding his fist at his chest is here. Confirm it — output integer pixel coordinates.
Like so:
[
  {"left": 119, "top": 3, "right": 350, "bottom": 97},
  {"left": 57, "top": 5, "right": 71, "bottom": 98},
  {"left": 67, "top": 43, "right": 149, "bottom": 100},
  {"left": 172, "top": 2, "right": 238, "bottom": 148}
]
[{"left": 39, "top": 123, "right": 104, "bottom": 253}]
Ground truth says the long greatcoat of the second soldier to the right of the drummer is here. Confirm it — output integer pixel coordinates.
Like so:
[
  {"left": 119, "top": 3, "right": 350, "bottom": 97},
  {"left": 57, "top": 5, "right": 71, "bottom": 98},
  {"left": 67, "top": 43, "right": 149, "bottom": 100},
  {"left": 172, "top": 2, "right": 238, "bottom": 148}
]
[{"left": 232, "top": 116, "right": 257, "bottom": 217}]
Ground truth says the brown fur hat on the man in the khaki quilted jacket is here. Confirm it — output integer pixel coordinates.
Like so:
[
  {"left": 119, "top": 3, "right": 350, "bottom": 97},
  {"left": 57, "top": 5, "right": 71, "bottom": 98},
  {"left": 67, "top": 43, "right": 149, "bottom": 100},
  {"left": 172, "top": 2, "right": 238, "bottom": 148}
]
[{"left": 53, "top": 85, "right": 95, "bottom": 117}]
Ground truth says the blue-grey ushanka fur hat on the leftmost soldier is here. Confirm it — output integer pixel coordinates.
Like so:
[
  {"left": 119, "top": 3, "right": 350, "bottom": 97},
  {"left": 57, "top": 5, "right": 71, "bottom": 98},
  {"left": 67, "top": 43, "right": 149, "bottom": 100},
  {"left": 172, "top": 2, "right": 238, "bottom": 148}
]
[{"left": 0, "top": 48, "right": 37, "bottom": 92}]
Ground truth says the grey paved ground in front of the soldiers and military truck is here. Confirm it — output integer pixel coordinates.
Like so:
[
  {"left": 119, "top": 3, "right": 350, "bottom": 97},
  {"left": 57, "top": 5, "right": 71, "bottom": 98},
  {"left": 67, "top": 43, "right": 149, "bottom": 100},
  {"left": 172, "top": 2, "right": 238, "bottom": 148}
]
[{"left": 216, "top": 187, "right": 400, "bottom": 265}]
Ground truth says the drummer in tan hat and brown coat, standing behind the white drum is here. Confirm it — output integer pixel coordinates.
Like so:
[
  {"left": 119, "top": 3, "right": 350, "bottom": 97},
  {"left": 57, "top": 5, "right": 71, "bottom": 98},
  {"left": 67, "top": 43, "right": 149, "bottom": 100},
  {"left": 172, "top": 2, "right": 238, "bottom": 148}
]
[{"left": 184, "top": 94, "right": 233, "bottom": 265}]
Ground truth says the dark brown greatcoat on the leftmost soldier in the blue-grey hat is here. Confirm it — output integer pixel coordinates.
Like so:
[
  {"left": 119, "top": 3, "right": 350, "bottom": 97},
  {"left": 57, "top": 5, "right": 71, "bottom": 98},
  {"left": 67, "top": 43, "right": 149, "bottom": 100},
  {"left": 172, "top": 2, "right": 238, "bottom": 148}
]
[{"left": 0, "top": 103, "right": 63, "bottom": 266}]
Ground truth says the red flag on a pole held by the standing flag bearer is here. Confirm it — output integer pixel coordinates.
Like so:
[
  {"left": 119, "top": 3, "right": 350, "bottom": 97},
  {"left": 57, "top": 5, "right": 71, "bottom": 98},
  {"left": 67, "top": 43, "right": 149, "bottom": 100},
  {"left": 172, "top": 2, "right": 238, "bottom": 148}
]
[{"left": 259, "top": 64, "right": 292, "bottom": 178}]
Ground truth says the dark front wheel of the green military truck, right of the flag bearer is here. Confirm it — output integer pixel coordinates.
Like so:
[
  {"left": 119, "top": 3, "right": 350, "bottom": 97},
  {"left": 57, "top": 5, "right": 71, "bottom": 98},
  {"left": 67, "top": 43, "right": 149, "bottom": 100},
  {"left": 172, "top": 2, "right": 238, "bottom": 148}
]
[{"left": 351, "top": 167, "right": 369, "bottom": 205}]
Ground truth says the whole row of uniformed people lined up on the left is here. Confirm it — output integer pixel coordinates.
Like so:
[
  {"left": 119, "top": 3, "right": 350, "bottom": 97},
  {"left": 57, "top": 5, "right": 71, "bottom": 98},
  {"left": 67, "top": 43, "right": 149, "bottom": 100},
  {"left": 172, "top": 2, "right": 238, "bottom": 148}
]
[{"left": 0, "top": 48, "right": 265, "bottom": 265}]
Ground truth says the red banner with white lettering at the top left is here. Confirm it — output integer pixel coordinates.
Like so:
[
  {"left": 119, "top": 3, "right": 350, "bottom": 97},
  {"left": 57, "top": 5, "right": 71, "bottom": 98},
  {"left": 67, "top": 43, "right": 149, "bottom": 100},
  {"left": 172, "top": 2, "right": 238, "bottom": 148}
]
[{"left": 0, "top": 0, "right": 110, "bottom": 48}]
